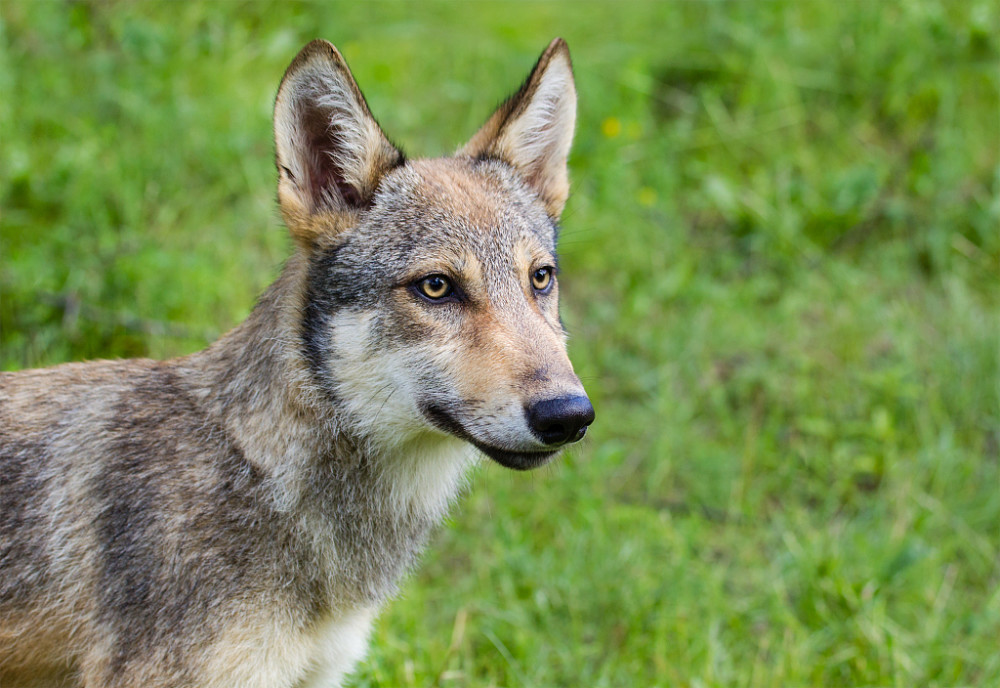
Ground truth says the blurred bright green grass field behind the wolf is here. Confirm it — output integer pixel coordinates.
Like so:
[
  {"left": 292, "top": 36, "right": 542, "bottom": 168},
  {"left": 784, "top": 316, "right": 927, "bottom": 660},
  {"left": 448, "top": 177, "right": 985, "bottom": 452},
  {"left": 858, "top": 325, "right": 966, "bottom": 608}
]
[{"left": 0, "top": 0, "right": 1000, "bottom": 688}]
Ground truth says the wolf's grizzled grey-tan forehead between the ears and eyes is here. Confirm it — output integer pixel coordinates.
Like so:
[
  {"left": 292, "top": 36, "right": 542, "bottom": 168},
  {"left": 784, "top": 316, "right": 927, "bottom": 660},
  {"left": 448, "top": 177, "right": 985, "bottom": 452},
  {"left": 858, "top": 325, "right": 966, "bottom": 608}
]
[{"left": 345, "top": 156, "right": 558, "bottom": 263}]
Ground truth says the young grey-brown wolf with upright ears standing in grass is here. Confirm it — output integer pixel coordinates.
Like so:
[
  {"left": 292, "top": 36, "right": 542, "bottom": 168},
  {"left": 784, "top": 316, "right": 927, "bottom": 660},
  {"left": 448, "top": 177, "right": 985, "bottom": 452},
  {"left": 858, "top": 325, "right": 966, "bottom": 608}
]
[{"left": 0, "top": 39, "right": 594, "bottom": 688}]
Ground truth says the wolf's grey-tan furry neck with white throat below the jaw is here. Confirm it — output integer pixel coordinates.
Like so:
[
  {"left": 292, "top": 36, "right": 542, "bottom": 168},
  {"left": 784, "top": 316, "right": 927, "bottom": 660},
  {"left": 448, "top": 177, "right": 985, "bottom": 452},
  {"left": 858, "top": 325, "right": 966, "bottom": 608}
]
[{"left": 181, "top": 255, "right": 474, "bottom": 583}]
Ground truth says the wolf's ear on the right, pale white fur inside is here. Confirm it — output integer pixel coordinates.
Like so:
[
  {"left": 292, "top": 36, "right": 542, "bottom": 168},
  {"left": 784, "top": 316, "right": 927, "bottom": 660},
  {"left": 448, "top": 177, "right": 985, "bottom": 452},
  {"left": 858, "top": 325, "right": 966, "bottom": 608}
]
[{"left": 459, "top": 38, "right": 576, "bottom": 217}]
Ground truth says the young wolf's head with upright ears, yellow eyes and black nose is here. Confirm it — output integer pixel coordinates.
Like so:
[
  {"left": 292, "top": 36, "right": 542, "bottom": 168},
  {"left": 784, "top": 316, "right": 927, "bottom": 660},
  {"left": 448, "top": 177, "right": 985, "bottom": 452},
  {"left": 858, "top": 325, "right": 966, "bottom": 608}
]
[{"left": 274, "top": 39, "right": 594, "bottom": 469}]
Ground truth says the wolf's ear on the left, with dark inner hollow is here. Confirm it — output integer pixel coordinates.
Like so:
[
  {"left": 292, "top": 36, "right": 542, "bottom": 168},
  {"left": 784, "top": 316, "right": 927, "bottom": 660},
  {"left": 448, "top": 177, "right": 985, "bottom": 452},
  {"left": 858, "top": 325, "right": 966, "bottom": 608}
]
[{"left": 274, "top": 39, "right": 404, "bottom": 244}]
